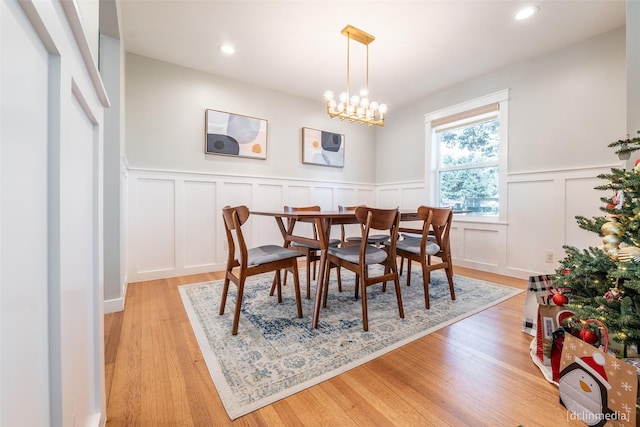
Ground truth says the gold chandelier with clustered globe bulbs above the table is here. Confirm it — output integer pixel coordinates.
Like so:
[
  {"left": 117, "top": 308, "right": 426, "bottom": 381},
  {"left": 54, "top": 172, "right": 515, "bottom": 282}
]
[{"left": 324, "top": 25, "right": 387, "bottom": 126}]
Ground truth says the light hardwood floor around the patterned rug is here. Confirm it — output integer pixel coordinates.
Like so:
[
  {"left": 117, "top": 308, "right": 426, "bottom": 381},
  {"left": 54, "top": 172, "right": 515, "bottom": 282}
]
[{"left": 105, "top": 267, "right": 583, "bottom": 427}]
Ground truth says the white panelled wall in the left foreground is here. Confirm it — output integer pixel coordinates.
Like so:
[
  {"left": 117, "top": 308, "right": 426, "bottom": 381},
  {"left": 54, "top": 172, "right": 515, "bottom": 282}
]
[{"left": 0, "top": 0, "right": 108, "bottom": 427}]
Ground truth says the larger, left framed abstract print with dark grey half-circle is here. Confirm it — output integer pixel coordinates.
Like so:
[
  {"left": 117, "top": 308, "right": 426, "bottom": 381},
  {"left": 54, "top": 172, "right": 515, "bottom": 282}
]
[{"left": 204, "top": 109, "right": 268, "bottom": 160}]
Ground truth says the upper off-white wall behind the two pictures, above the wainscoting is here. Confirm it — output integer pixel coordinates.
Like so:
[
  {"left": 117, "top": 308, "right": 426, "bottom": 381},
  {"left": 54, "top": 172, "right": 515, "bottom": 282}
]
[{"left": 126, "top": 54, "right": 376, "bottom": 183}]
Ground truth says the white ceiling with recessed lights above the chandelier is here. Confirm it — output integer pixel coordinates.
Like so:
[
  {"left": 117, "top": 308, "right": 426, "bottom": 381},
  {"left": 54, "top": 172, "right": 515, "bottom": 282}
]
[{"left": 116, "top": 0, "right": 625, "bottom": 111}]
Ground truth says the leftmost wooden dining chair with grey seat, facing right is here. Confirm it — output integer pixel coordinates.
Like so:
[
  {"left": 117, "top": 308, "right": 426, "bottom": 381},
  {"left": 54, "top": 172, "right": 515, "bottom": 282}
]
[{"left": 220, "top": 206, "right": 302, "bottom": 335}]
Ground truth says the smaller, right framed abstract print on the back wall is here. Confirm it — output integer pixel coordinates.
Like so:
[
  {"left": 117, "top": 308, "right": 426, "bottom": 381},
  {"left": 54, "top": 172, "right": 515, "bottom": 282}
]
[{"left": 302, "top": 127, "right": 345, "bottom": 168}]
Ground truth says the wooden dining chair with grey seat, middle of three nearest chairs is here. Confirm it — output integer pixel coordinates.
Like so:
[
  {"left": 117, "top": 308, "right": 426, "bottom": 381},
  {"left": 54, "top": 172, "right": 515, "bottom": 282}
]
[{"left": 323, "top": 206, "right": 404, "bottom": 331}]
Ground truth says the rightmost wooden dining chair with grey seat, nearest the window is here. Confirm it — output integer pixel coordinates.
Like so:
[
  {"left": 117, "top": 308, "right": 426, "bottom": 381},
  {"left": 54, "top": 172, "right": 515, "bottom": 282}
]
[{"left": 396, "top": 206, "right": 456, "bottom": 308}]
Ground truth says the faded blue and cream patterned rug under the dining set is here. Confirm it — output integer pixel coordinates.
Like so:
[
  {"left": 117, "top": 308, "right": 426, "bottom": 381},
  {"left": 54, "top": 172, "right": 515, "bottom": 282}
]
[{"left": 179, "top": 268, "right": 522, "bottom": 420}]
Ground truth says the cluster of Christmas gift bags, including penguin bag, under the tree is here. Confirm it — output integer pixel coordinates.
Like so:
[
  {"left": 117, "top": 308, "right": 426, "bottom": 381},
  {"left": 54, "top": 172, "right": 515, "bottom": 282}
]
[{"left": 522, "top": 275, "right": 640, "bottom": 426}]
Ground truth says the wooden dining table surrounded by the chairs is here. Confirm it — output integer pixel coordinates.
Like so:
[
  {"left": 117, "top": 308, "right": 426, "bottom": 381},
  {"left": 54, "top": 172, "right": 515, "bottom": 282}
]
[{"left": 251, "top": 209, "right": 422, "bottom": 329}]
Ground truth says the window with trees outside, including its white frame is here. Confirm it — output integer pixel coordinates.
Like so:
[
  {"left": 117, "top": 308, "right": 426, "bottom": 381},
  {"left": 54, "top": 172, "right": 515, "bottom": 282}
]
[{"left": 427, "top": 91, "right": 508, "bottom": 220}]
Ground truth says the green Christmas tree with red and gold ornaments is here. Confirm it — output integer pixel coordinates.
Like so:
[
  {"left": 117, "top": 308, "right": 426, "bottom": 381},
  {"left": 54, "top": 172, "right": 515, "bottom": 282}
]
[{"left": 555, "top": 131, "right": 640, "bottom": 349}]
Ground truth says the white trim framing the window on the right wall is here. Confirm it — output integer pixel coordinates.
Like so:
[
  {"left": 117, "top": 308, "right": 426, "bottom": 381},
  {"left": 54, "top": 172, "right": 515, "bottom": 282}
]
[{"left": 424, "top": 89, "right": 509, "bottom": 223}]
